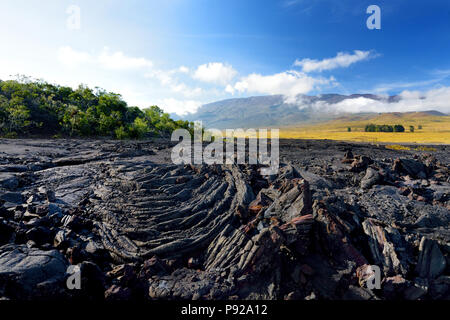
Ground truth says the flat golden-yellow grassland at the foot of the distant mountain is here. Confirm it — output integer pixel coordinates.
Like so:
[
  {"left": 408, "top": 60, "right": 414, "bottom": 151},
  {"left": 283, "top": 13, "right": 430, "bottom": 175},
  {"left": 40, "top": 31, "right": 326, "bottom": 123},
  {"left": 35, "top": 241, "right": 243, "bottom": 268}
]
[{"left": 280, "top": 113, "right": 450, "bottom": 144}]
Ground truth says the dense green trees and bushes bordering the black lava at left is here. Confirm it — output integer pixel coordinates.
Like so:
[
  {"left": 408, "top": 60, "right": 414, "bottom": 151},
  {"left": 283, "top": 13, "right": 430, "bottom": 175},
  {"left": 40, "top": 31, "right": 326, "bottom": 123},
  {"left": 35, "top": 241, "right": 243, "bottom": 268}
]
[{"left": 0, "top": 77, "right": 189, "bottom": 139}]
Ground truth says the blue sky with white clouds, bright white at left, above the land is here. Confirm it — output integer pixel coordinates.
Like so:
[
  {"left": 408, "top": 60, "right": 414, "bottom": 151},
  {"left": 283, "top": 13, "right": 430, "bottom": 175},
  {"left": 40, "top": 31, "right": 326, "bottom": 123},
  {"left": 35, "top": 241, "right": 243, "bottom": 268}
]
[{"left": 0, "top": 0, "right": 450, "bottom": 114}]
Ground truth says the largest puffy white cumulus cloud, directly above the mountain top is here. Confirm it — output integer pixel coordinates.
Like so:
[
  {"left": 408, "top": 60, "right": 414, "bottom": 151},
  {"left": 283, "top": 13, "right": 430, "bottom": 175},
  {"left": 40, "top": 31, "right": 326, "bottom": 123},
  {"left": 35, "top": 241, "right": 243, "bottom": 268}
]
[{"left": 230, "top": 70, "right": 334, "bottom": 101}]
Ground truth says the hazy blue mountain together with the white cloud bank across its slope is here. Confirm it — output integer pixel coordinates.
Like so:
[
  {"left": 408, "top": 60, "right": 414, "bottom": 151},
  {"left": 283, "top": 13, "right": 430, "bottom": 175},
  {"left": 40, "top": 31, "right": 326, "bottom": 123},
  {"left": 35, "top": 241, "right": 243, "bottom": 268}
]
[{"left": 186, "top": 88, "right": 450, "bottom": 129}]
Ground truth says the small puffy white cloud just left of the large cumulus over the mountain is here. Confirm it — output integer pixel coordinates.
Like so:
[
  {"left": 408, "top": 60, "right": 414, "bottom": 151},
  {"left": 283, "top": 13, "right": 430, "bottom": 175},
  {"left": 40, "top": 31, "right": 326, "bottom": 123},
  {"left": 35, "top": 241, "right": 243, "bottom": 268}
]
[{"left": 192, "top": 62, "right": 237, "bottom": 85}]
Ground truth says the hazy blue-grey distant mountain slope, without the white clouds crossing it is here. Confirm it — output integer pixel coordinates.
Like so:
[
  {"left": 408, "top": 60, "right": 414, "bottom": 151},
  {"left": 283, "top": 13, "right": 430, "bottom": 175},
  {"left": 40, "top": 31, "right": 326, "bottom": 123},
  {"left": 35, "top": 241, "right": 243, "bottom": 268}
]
[{"left": 183, "top": 94, "right": 445, "bottom": 129}]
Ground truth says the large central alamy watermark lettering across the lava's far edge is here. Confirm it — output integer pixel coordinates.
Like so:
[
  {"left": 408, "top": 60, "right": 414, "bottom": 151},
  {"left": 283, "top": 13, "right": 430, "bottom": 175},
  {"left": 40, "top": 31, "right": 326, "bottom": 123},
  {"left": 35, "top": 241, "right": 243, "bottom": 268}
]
[{"left": 171, "top": 121, "right": 280, "bottom": 175}]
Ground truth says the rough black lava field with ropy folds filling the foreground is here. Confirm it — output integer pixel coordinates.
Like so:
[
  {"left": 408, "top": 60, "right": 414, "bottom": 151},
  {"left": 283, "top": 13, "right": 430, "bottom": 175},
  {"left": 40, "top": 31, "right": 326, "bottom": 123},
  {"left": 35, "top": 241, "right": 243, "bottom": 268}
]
[{"left": 0, "top": 140, "right": 450, "bottom": 301}]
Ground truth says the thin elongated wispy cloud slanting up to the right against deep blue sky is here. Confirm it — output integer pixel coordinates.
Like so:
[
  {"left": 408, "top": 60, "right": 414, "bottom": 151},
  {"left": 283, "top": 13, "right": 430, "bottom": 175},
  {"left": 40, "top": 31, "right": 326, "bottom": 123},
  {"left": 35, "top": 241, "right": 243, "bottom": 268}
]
[{"left": 294, "top": 50, "right": 371, "bottom": 72}]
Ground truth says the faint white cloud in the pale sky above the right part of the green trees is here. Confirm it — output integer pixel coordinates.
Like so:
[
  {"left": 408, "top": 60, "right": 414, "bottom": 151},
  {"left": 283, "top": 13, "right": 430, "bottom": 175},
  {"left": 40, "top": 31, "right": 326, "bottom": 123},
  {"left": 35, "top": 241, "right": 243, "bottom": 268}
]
[{"left": 98, "top": 48, "right": 153, "bottom": 70}]
